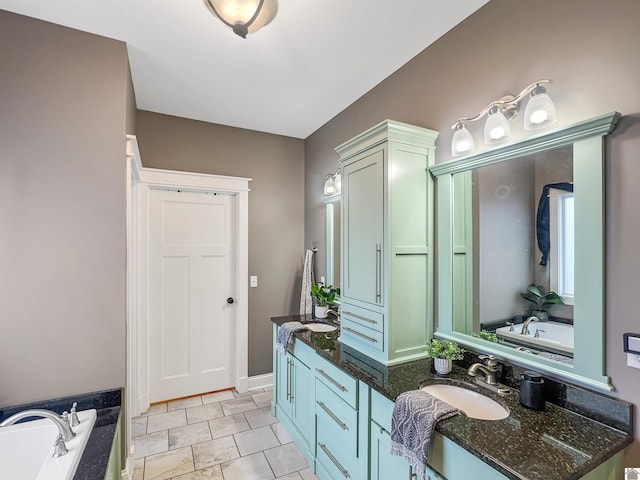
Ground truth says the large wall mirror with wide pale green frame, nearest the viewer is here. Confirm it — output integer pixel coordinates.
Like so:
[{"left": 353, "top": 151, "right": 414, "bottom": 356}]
[{"left": 430, "top": 112, "right": 620, "bottom": 390}]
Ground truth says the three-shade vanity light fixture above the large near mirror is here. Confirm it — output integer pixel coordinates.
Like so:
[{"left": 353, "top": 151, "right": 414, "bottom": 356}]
[{"left": 451, "top": 79, "right": 556, "bottom": 157}]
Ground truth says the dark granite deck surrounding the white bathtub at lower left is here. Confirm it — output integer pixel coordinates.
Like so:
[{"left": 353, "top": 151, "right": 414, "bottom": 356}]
[{"left": 0, "top": 389, "right": 122, "bottom": 480}]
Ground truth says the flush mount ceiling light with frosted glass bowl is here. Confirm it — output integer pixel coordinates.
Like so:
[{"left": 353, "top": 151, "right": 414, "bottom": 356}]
[{"left": 203, "top": 0, "right": 278, "bottom": 38}]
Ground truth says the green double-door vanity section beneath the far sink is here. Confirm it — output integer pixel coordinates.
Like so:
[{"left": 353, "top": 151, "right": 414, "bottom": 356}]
[{"left": 273, "top": 327, "right": 316, "bottom": 465}]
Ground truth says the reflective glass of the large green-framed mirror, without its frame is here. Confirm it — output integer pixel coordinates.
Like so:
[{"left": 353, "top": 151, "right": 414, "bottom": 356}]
[{"left": 453, "top": 146, "right": 574, "bottom": 363}]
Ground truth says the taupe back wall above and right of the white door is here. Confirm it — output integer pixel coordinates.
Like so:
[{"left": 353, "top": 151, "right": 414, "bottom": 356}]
[{"left": 136, "top": 111, "right": 304, "bottom": 376}]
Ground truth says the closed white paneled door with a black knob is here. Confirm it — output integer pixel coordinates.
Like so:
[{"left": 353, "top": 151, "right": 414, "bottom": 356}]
[{"left": 148, "top": 188, "right": 236, "bottom": 402}]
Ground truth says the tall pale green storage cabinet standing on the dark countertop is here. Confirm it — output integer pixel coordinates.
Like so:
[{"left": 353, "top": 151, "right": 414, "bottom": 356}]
[{"left": 336, "top": 120, "right": 438, "bottom": 365}]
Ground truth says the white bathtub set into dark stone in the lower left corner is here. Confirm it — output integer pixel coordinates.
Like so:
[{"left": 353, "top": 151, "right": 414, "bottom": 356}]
[{"left": 0, "top": 410, "right": 96, "bottom": 480}]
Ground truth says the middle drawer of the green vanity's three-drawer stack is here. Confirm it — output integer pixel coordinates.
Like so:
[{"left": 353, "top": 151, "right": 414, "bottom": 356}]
[{"left": 316, "top": 380, "right": 358, "bottom": 456}]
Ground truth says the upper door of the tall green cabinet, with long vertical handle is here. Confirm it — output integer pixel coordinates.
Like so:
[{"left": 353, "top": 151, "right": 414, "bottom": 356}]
[{"left": 342, "top": 148, "right": 385, "bottom": 305}]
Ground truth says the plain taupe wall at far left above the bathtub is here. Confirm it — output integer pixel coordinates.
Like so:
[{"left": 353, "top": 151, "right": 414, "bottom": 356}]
[{"left": 0, "top": 11, "right": 128, "bottom": 406}]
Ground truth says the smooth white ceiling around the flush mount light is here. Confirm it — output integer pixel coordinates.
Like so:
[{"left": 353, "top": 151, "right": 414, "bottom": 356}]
[{"left": 0, "top": 0, "right": 488, "bottom": 138}]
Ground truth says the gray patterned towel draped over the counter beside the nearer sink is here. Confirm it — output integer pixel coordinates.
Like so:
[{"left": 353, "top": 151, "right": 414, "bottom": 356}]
[{"left": 391, "top": 390, "right": 459, "bottom": 478}]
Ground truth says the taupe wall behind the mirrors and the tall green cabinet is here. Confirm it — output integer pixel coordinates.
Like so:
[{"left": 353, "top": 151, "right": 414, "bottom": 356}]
[{"left": 305, "top": 0, "right": 640, "bottom": 466}]
